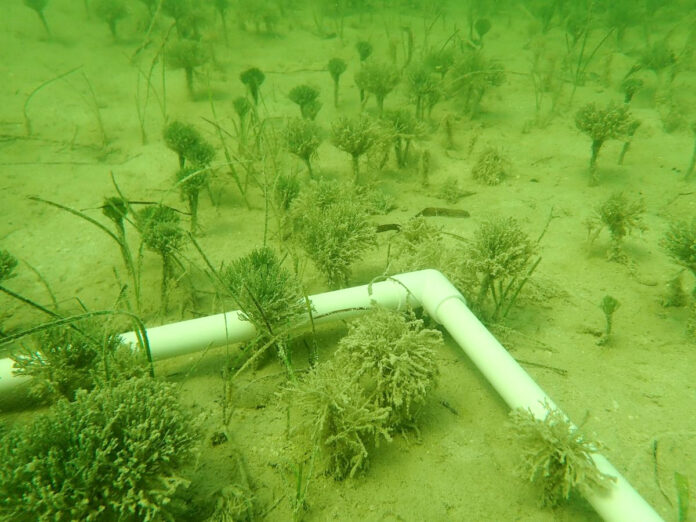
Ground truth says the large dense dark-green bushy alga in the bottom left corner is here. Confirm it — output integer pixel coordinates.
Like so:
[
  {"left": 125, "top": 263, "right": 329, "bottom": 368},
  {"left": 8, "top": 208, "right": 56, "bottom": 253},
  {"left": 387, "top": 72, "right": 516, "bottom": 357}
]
[{"left": 0, "top": 377, "right": 199, "bottom": 520}]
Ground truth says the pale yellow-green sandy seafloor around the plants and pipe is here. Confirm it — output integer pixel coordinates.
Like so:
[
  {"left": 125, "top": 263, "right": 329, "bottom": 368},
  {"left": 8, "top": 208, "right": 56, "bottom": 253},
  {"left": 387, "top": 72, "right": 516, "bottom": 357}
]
[{"left": 0, "top": 0, "right": 696, "bottom": 521}]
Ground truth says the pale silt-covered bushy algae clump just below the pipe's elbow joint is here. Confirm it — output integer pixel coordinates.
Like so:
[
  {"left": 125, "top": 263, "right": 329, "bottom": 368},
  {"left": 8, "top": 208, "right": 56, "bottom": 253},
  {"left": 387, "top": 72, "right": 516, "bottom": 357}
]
[{"left": 287, "top": 309, "right": 442, "bottom": 480}]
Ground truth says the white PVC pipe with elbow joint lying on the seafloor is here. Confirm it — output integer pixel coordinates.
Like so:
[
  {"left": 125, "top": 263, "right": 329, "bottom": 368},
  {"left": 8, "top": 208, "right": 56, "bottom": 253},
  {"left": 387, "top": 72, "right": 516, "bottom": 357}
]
[{"left": 0, "top": 270, "right": 662, "bottom": 522}]
